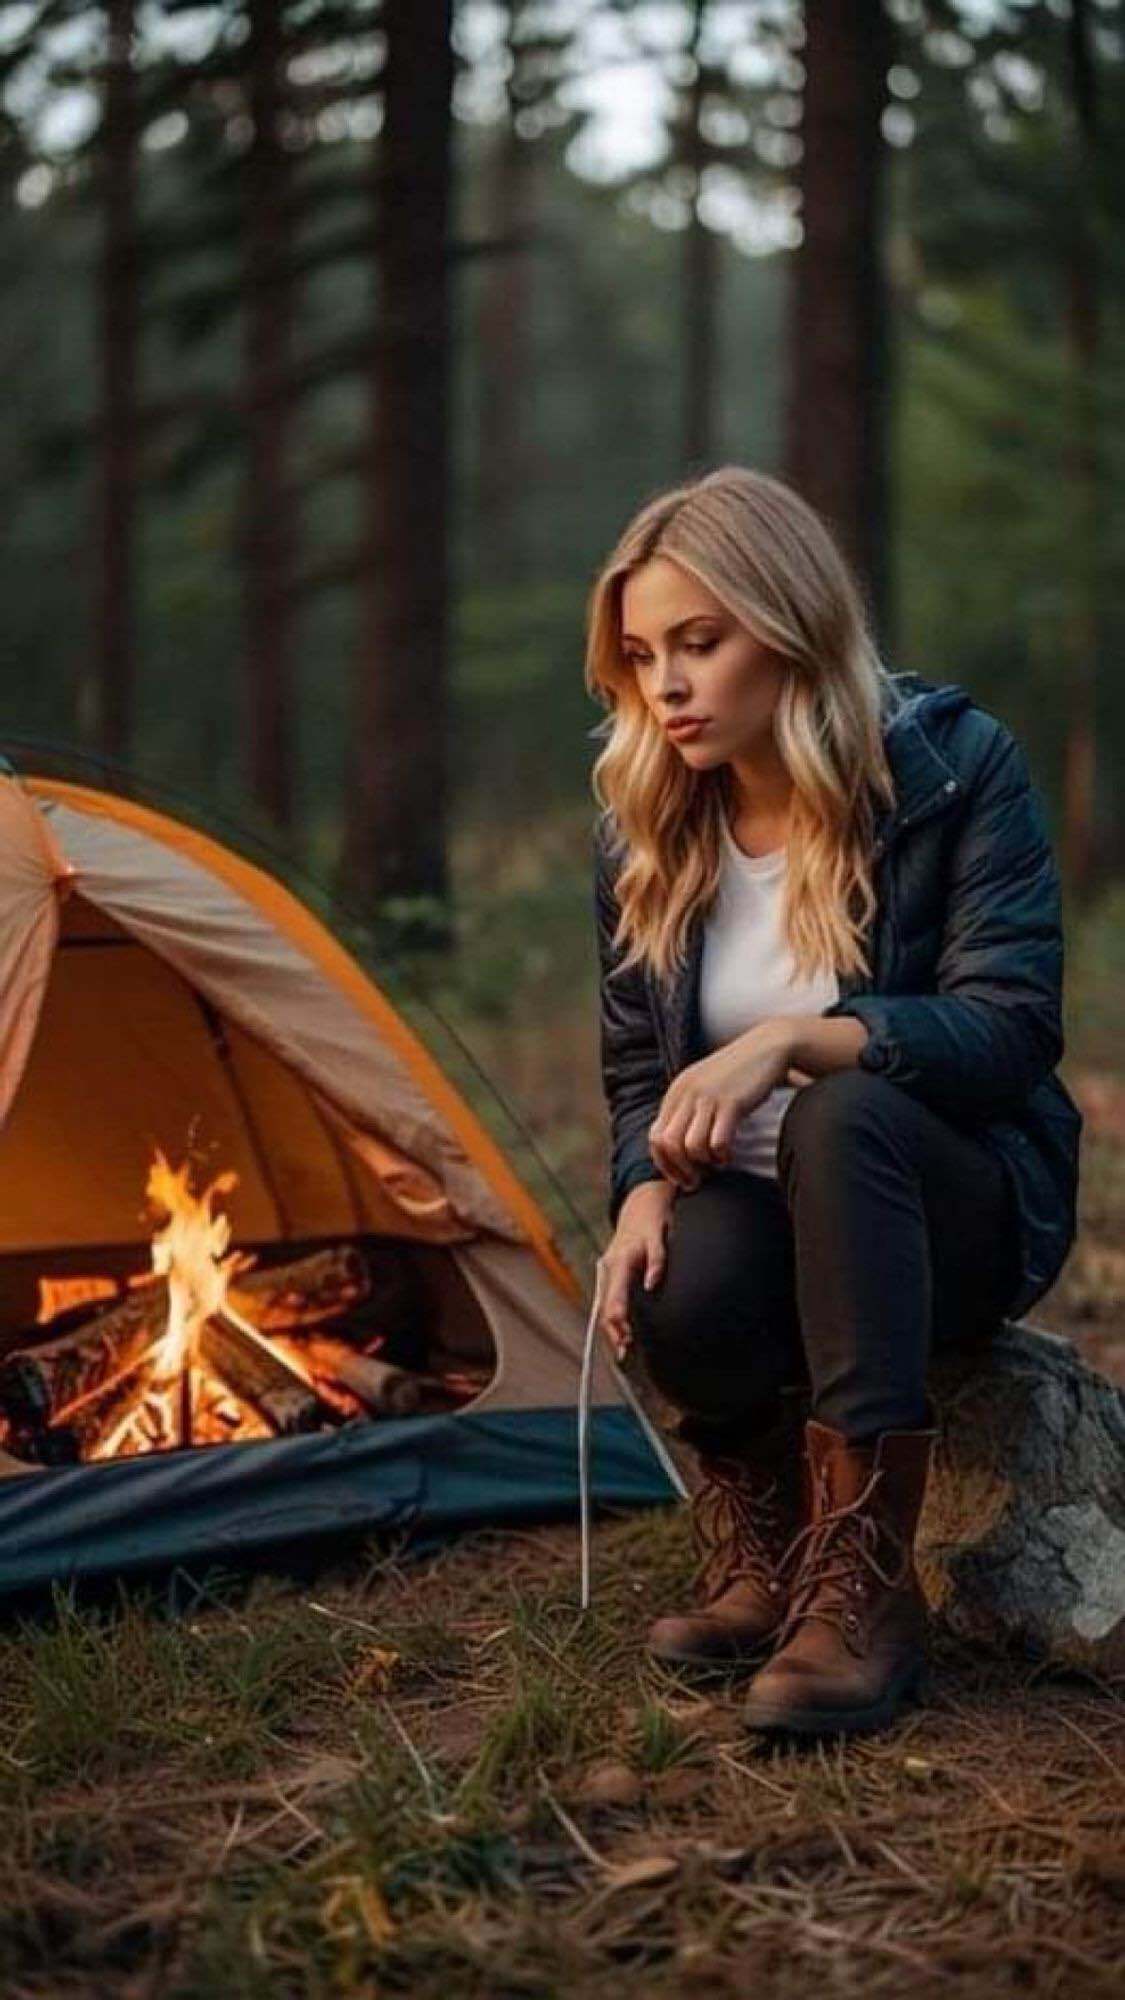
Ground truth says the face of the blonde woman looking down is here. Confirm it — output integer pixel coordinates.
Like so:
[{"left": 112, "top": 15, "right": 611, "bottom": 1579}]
[{"left": 621, "top": 556, "right": 789, "bottom": 770}]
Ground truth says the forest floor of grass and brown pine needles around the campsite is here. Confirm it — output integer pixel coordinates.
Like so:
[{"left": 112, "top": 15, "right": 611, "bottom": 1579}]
[{"left": 0, "top": 848, "right": 1125, "bottom": 2000}]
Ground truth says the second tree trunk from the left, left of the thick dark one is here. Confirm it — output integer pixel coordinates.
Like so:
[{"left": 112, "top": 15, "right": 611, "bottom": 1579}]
[{"left": 242, "top": 0, "right": 294, "bottom": 836}]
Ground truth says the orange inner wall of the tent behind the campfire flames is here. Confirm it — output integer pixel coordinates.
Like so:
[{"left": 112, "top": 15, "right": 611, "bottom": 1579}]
[{"left": 0, "top": 902, "right": 474, "bottom": 1250}]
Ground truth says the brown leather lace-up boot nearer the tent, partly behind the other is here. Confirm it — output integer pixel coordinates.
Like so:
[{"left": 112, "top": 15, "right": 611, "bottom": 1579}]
[{"left": 649, "top": 1398, "right": 809, "bottom": 1670}]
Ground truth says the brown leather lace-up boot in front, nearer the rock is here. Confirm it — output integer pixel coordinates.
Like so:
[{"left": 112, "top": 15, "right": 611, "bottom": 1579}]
[{"left": 743, "top": 1418, "right": 937, "bottom": 1734}]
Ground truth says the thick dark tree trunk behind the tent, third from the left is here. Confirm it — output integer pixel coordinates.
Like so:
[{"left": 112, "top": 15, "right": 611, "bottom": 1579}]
[{"left": 336, "top": 0, "right": 452, "bottom": 920}]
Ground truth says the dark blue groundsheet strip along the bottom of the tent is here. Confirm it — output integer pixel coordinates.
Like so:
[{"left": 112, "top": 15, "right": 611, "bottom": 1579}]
[{"left": 0, "top": 1408, "right": 673, "bottom": 1596}]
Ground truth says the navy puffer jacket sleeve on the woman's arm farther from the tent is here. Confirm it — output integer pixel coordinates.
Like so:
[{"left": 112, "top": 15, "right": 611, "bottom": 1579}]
[{"left": 812, "top": 722, "right": 1063, "bottom": 1122}]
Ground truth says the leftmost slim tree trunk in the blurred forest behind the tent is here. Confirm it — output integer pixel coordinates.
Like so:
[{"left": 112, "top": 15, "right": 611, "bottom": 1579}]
[{"left": 93, "top": 0, "right": 140, "bottom": 758}]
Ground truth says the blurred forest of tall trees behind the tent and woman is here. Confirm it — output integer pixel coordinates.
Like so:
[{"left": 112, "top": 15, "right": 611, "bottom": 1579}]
[{"left": 0, "top": 0, "right": 1125, "bottom": 1280}]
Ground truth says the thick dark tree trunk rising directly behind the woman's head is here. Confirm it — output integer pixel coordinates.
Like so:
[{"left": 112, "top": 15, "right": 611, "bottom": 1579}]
[{"left": 785, "top": 0, "right": 893, "bottom": 642}]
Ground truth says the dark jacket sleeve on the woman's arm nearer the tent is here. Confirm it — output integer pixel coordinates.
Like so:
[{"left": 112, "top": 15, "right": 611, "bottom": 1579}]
[{"left": 595, "top": 830, "right": 669, "bottom": 1228}]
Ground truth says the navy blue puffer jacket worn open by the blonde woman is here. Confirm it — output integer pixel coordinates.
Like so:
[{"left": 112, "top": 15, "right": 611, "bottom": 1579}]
[{"left": 595, "top": 674, "right": 1083, "bottom": 1316}]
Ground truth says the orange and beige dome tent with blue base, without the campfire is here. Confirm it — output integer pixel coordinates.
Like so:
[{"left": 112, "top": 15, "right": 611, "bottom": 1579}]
[{"left": 0, "top": 776, "right": 648, "bottom": 1592}]
